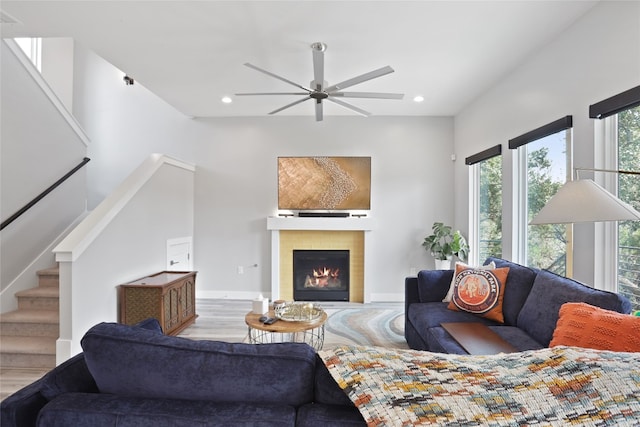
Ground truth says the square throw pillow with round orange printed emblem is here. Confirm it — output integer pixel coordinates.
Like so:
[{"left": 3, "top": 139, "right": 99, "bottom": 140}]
[{"left": 448, "top": 265, "right": 509, "bottom": 323}]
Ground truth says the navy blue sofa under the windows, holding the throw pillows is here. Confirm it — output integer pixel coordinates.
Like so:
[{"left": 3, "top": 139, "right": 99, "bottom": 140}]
[{"left": 404, "top": 258, "right": 631, "bottom": 354}]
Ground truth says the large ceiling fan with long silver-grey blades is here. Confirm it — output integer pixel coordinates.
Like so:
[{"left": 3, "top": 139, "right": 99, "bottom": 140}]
[{"left": 236, "top": 42, "right": 404, "bottom": 122}]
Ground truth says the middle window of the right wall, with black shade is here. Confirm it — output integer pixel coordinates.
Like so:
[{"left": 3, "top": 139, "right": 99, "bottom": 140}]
[{"left": 509, "top": 116, "right": 573, "bottom": 276}]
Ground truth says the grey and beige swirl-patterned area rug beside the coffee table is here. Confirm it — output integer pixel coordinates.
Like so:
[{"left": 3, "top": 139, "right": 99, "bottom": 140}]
[{"left": 324, "top": 307, "right": 409, "bottom": 349}]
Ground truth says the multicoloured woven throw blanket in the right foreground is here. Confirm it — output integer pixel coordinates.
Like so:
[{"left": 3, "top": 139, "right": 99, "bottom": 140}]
[{"left": 319, "top": 346, "right": 640, "bottom": 426}]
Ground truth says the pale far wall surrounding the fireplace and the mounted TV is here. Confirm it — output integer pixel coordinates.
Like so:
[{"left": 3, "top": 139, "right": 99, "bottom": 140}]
[{"left": 188, "top": 116, "right": 453, "bottom": 300}]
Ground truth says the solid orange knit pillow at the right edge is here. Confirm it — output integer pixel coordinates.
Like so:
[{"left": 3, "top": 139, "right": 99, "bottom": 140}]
[{"left": 549, "top": 302, "right": 640, "bottom": 352}]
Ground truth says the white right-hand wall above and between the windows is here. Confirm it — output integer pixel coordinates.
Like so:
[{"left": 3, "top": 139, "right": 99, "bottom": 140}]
[{"left": 455, "top": 2, "right": 640, "bottom": 284}]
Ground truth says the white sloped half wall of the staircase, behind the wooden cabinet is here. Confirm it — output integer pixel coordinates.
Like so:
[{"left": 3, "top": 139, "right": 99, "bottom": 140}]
[{"left": 54, "top": 156, "right": 194, "bottom": 363}]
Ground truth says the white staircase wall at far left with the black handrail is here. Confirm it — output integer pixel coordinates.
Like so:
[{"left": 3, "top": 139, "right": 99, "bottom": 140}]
[{"left": 0, "top": 41, "right": 87, "bottom": 302}]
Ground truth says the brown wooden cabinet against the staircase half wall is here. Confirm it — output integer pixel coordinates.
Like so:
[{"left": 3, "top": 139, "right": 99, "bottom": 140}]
[{"left": 118, "top": 271, "right": 197, "bottom": 335}]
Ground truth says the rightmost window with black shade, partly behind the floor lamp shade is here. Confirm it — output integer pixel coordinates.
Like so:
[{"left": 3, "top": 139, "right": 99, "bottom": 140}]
[{"left": 589, "top": 86, "right": 640, "bottom": 310}]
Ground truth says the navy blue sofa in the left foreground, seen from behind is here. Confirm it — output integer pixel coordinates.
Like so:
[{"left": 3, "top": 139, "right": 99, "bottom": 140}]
[{"left": 0, "top": 319, "right": 366, "bottom": 427}]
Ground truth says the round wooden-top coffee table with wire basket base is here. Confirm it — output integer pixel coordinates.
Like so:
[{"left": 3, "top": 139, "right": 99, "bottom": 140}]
[{"left": 244, "top": 309, "right": 328, "bottom": 350}]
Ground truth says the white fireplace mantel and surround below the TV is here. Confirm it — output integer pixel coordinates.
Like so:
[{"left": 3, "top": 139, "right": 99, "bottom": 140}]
[{"left": 267, "top": 216, "right": 375, "bottom": 303}]
